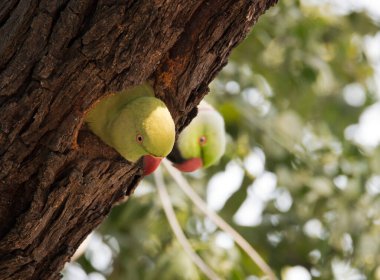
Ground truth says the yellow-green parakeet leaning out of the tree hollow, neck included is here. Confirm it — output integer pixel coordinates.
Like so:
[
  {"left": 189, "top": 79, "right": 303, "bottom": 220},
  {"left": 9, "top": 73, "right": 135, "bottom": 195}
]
[{"left": 85, "top": 84, "right": 175, "bottom": 175}]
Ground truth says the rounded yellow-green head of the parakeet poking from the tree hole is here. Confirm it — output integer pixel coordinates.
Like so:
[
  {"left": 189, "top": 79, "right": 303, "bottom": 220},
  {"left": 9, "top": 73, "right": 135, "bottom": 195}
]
[{"left": 110, "top": 96, "right": 175, "bottom": 174}]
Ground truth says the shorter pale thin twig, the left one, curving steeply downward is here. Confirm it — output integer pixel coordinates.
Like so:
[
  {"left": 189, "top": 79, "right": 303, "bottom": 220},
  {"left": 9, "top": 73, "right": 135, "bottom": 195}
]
[{"left": 154, "top": 168, "right": 220, "bottom": 280}]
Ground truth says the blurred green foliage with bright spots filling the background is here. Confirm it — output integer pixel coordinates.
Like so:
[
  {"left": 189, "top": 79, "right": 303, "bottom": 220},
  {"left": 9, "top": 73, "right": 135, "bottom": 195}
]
[{"left": 65, "top": 0, "right": 380, "bottom": 280}]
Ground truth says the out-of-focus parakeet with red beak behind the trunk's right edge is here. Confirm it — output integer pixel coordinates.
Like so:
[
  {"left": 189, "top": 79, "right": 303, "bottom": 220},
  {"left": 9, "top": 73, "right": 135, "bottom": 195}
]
[{"left": 168, "top": 101, "right": 226, "bottom": 172}]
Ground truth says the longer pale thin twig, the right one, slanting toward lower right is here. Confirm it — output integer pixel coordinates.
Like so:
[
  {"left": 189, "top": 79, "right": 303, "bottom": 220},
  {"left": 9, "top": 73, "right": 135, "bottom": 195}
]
[{"left": 163, "top": 159, "right": 277, "bottom": 280}]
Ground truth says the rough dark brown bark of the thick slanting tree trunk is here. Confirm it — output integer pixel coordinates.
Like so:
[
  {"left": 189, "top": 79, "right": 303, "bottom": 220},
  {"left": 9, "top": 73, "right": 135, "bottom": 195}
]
[{"left": 0, "top": 0, "right": 277, "bottom": 279}]
